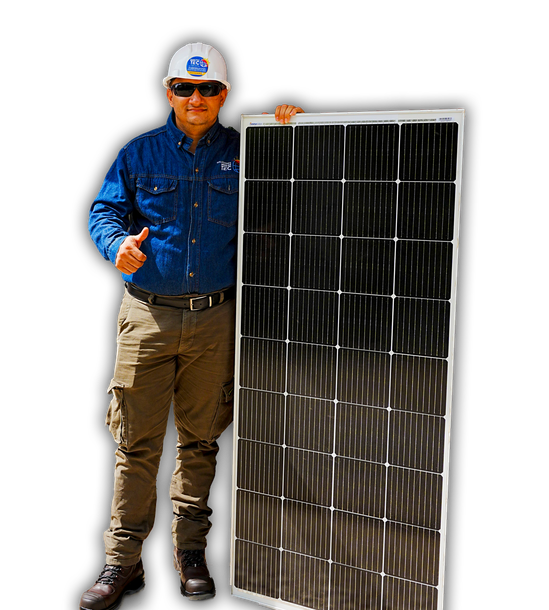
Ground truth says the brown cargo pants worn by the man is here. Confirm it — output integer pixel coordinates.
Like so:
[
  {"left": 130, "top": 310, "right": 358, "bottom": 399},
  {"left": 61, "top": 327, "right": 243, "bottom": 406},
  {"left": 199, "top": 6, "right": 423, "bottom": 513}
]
[{"left": 104, "top": 290, "right": 235, "bottom": 566}]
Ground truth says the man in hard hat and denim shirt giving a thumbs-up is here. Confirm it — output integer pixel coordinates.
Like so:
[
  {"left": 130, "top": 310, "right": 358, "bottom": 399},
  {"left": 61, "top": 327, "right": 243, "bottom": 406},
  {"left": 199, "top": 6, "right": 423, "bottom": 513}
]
[{"left": 80, "top": 43, "right": 303, "bottom": 610}]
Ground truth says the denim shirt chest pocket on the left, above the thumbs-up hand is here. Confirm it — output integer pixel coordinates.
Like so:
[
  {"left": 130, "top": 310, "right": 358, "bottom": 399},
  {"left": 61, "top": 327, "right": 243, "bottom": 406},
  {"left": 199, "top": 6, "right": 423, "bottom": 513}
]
[{"left": 135, "top": 177, "right": 177, "bottom": 225}]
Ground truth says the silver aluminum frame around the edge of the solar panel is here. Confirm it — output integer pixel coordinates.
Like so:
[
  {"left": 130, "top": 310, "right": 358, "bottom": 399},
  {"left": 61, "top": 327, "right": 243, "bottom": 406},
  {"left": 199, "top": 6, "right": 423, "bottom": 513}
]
[{"left": 230, "top": 109, "right": 465, "bottom": 610}]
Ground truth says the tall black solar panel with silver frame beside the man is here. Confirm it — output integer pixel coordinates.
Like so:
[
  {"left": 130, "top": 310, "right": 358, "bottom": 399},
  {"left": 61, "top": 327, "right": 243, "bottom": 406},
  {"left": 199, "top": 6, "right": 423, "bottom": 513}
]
[{"left": 231, "top": 111, "right": 464, "bottom": 610}]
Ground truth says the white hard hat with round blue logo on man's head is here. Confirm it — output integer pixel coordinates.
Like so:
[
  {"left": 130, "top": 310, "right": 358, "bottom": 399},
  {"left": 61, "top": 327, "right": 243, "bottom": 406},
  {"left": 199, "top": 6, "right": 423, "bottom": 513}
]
[{"left": 162, "top": 42, "right": 231, "bottom": 91}]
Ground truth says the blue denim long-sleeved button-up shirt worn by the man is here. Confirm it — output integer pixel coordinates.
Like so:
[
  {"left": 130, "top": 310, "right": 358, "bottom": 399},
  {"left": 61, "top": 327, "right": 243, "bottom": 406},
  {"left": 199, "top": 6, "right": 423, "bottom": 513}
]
[{"left": 88, "top": 111, "right": 240, "bottom": 295}]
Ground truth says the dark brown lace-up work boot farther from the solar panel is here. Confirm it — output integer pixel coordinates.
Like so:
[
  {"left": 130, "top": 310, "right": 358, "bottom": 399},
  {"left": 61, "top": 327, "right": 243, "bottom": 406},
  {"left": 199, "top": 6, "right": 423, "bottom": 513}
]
[{"left": 79, "top": 560, "right": 145, "bottom": 610}]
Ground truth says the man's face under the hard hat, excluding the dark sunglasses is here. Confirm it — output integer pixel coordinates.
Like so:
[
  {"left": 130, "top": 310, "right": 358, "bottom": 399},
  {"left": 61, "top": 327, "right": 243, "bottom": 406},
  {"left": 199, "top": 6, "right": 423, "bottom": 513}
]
[{"left": 166, "top": 78, "right": 228, "bottom": 133}]
